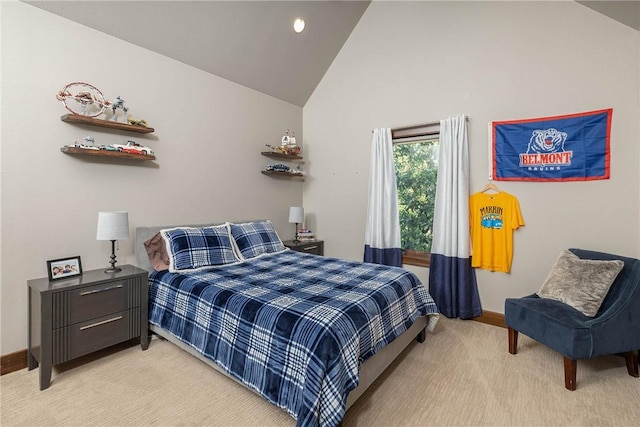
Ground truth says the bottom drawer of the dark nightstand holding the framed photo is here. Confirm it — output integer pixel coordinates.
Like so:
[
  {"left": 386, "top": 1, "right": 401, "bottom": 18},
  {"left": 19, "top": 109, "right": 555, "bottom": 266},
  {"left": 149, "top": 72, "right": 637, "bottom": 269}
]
[{"left": 52, "top": 308, "right": 140, "bottom": 365}]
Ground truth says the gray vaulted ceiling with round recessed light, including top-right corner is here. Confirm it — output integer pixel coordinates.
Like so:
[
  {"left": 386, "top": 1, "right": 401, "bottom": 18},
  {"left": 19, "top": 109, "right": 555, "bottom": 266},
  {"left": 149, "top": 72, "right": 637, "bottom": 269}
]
[{"left": 24, "top": 0, "right": 640, "bottom": 106}]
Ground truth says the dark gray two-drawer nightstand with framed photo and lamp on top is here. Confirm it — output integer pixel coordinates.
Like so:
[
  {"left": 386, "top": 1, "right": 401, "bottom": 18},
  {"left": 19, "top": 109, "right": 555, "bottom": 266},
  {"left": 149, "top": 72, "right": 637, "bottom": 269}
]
[{"left": 27, "top": 265, "right": 149, "bottom": 390}]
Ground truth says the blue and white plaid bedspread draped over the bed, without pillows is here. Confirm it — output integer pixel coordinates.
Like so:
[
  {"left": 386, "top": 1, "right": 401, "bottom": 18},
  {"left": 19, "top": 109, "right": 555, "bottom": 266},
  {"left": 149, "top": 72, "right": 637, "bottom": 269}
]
[{"left": 149, "top": 250, "right": 437, "bottom": 426}]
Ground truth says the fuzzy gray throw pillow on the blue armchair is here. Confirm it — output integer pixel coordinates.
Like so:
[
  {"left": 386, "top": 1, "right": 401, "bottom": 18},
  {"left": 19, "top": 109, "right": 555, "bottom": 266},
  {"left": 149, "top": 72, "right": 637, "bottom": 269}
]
[{"left": 538, "top": 251, "right": 624, "bottom": 317}]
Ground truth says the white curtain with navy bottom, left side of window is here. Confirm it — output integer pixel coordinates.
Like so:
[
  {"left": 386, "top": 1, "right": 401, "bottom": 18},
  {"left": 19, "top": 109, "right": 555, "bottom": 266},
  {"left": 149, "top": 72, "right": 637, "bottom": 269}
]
[{"left": 364, "top": 128, "right": 402, "bottom": 267}]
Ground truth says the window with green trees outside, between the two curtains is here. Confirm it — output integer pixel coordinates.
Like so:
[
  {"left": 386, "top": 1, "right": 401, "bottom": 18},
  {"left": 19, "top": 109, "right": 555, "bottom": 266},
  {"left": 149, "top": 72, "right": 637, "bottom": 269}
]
[{"left": 393, "top": 127, "right": 439, "bottom": 267}]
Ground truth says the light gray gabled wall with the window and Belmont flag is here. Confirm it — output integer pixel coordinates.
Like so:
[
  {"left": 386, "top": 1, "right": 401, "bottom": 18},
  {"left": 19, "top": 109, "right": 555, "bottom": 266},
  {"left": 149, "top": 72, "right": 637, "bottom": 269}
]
[{"left": 304, "top": 2, "right": 640, "bottom": 312}]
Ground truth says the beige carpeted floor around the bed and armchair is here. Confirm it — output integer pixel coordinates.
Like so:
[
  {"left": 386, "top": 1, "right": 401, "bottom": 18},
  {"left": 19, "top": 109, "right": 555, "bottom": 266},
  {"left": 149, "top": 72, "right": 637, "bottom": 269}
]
[{"left": 0, "top": 317, "right": 640, "bottom": 427}]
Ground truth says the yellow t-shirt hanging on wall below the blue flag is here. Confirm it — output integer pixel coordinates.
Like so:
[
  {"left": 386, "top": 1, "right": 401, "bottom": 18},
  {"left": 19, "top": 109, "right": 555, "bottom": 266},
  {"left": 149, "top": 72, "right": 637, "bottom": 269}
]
[{"left": 469, "top": 191, "right": 524, "bottom": 273}]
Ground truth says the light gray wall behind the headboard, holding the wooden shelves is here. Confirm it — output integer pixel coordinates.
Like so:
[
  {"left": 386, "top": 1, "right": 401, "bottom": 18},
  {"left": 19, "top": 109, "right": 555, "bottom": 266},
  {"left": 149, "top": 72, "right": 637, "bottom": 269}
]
[{"left": 0, "top": 2, "right": 303, "bottom": 354}]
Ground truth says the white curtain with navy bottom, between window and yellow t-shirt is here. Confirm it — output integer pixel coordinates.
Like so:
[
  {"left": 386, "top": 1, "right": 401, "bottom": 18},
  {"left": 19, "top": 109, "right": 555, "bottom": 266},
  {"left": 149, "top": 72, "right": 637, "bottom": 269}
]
[{"left": 429, "top": 116, "right": 482, "bottom": 319}]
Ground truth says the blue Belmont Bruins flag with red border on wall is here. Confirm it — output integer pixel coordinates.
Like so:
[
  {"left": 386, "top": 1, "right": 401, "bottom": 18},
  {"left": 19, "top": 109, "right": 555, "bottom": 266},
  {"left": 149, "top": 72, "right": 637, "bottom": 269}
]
[{"left": 491, "top": 108, "right": 613, "bottom": 181}]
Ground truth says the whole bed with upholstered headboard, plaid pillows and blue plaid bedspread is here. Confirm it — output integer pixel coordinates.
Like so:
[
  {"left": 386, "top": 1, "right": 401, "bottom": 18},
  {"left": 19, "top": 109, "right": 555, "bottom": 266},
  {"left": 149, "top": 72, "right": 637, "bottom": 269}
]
[{"left": 136, "top": 220, "right": 438, "bottom": 426}]
